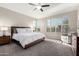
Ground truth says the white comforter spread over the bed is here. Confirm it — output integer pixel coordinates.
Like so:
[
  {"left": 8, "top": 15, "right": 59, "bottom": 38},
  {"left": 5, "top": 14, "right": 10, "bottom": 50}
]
[{"left": 12, "top": 32, "right": 45, "bottom": 48}]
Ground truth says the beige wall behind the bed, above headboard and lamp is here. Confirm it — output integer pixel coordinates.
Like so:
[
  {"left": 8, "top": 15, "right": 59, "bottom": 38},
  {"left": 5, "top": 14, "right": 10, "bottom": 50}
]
[{"left": 0, "top": 7, "right": 33, "bottom": 26}]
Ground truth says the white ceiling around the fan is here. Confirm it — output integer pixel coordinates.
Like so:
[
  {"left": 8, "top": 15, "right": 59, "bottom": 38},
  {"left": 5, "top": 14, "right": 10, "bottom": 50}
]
[{"left": 0, "top": 3, "right": 78, "bottom": 18}]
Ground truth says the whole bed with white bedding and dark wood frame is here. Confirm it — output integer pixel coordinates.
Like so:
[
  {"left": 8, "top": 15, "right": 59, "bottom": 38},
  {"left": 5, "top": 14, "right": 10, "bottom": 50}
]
[{"left": 11, "top": 26, "right": 45, "bottom": 48}]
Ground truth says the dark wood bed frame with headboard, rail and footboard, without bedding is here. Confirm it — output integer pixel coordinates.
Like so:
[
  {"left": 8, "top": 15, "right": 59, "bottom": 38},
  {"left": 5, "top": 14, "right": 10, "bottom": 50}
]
[{"left": 11, "top": 26, "right": 45, "bottom": 49}]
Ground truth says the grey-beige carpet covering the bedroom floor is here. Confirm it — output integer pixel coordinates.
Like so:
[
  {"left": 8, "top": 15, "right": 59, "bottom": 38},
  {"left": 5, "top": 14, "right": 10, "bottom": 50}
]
[{"left": 0, "top": 40, "right": 74, "bottom": 56}]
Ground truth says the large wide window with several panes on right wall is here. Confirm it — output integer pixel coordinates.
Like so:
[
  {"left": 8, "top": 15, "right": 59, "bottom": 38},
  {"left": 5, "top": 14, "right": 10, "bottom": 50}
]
[{"left": 46, "top": 16, "right": 69, "bottom": 33}]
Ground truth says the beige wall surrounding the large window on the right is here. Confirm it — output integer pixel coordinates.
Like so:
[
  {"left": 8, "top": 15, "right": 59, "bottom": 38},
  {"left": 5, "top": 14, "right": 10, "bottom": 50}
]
[{"left": 41, "top": 11, "right": 77, "bottom": 39}]
